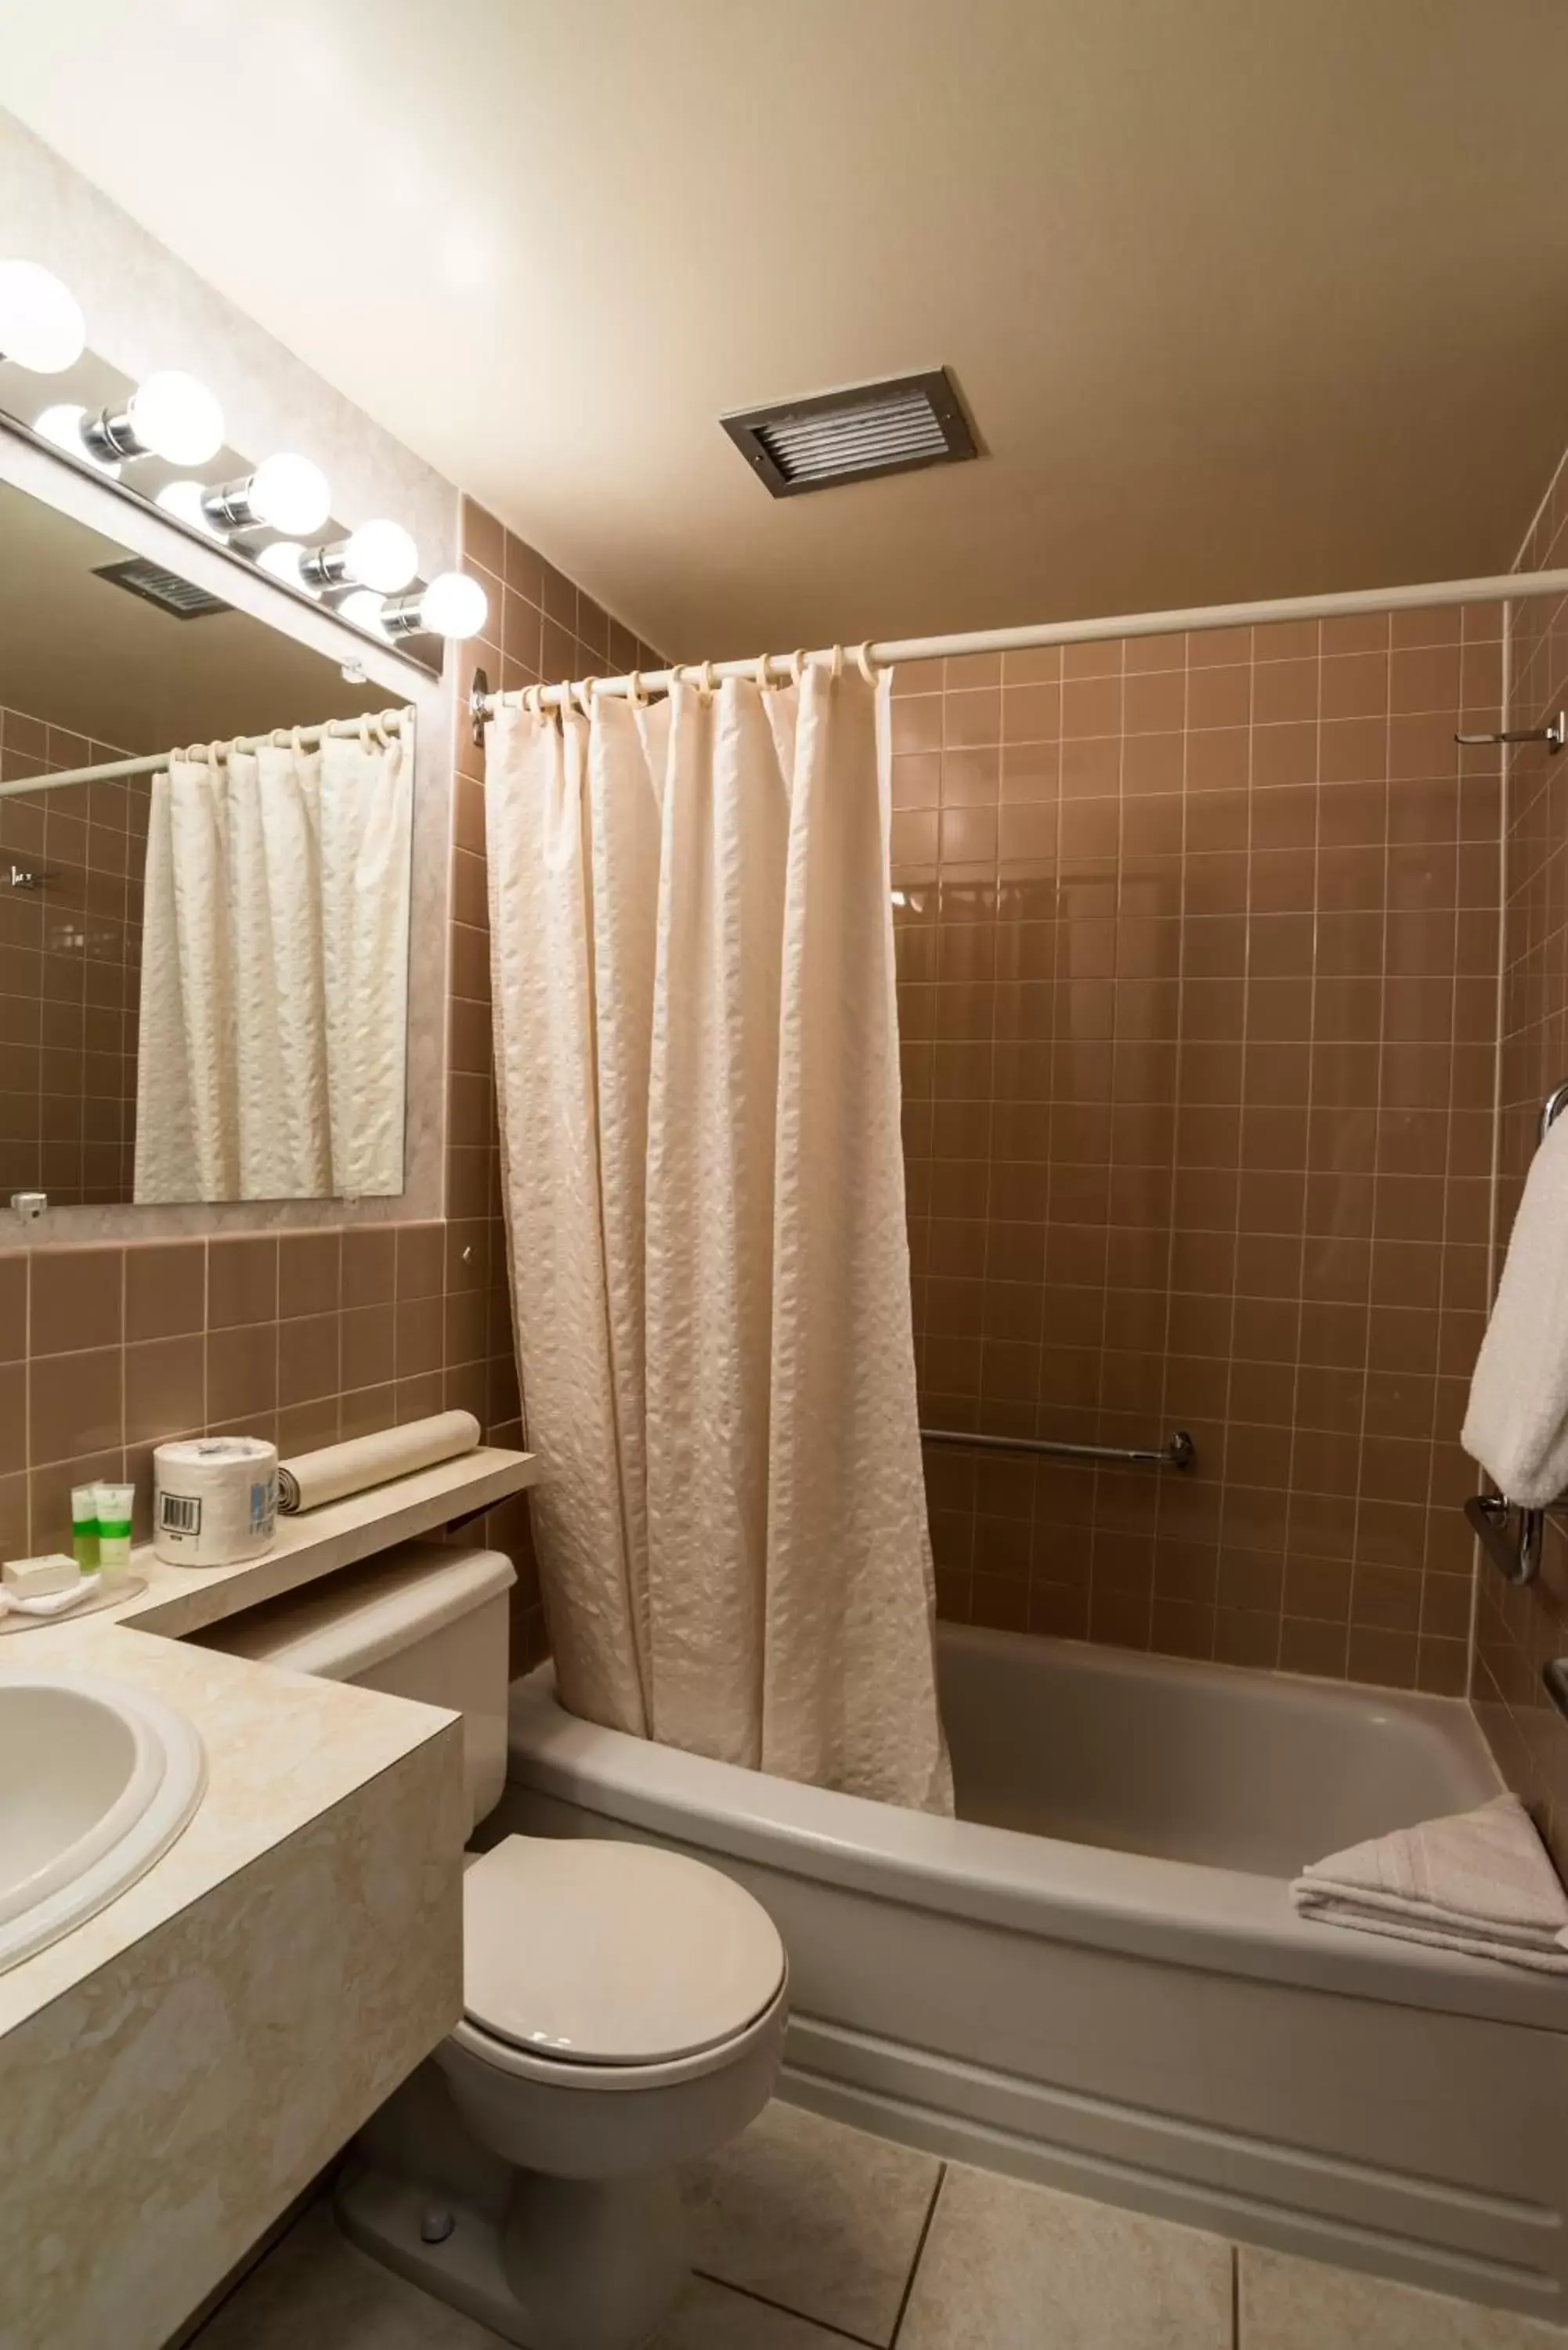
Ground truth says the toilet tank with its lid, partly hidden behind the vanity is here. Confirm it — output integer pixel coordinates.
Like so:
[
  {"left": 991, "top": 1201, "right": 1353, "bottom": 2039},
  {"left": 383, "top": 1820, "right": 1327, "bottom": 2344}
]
[{"left": 193, "top": 1542, "right": 517, "bottom": 1828}]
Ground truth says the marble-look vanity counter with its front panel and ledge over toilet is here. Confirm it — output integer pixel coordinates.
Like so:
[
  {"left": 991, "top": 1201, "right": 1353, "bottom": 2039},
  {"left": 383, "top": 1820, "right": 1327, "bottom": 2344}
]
[{"left": 0, "top": 1448, "right": 536, "bottom": 2350}]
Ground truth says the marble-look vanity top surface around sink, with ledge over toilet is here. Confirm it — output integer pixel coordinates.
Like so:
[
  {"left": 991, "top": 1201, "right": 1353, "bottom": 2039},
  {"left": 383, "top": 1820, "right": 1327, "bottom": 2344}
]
[{"left": 0, "top": 1445, "right": 538, "bottom": 2035}]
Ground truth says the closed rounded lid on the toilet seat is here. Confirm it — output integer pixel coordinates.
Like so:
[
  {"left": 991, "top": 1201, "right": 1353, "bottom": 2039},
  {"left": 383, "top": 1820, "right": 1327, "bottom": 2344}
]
[{"left": 463, "top": 1835, "right": 786, "bottom": 2066}]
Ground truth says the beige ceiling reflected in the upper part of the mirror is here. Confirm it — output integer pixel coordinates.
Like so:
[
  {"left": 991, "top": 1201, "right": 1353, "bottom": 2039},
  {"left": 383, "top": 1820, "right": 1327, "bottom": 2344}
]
[{"left": 0, "top": 486, "right": 385, "bottom": 752}]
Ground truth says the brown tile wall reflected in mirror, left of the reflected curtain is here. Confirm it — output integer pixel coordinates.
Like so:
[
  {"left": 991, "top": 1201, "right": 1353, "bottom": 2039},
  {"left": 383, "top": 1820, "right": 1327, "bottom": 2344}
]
[{"left": 0, "top": 705, "right": 150, "bottom": 1208}]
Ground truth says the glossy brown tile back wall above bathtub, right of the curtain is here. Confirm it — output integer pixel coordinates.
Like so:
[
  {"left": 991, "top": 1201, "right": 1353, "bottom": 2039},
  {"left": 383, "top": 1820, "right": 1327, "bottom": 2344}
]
[{"left": 894, "top": 609, "right": 1502, "bottom": 1692}]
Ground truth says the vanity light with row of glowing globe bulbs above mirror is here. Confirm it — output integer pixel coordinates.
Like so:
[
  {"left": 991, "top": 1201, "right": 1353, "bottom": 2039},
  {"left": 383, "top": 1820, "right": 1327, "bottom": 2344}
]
[{"left": 0, "top": 261, "right": 489, "bottom": 644}]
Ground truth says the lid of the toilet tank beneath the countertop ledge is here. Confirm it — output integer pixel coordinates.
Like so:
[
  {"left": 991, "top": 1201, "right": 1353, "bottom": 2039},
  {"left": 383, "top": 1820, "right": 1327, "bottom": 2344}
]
[{"left": 202, "top": 1542, "right": 517, "bottom": 1680}]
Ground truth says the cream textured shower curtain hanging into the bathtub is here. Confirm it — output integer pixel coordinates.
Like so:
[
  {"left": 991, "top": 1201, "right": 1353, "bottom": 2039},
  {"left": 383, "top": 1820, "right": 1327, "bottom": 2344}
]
[{"left": 484, "top": 667, "right": 952, "bottom": 1810}]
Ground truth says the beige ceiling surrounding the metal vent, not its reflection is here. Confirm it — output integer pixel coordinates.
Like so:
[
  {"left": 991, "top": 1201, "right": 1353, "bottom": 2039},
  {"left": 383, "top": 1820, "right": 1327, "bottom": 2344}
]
[{"left": 0, "top": 0, "right": 1568, "bottom": 658}]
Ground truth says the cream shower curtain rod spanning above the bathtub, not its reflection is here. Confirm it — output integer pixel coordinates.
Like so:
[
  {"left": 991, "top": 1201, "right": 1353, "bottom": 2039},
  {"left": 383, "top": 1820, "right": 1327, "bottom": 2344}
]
[{"left": 468, "top": 571, "right": 1568, "bottom": 719}]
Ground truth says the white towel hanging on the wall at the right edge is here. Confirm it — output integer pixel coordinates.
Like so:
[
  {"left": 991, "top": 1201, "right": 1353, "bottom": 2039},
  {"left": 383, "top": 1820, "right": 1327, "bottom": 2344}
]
[{"left": 1460, "top": 1119, "right": 1568, "bottom": 1509}]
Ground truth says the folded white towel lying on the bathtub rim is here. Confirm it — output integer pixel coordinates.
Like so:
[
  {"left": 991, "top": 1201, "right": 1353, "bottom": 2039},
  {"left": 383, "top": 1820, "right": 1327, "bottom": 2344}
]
[{"left": 1291, "top": 1795, "right": 1568, "bottom": 1974}]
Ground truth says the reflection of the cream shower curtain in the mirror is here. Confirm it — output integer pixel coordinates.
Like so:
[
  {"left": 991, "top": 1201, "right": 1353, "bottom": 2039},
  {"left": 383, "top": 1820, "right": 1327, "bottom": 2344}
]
[{"left": 134, "top": 731, "right": 414, "bottom": 1206}]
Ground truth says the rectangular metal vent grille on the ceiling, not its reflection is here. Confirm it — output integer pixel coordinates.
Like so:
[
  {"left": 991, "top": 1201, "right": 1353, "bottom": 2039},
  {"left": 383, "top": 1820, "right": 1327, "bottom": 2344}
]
[{"left": 719, "top": 367, "right": 978, "bottom": 498}]
